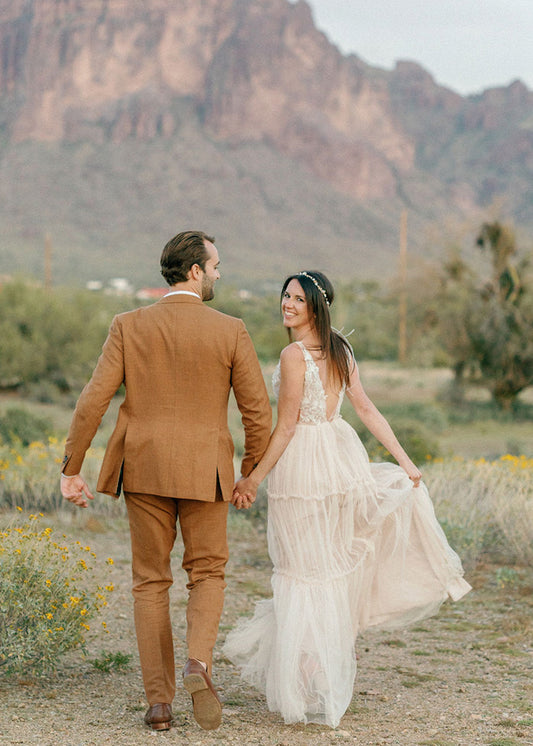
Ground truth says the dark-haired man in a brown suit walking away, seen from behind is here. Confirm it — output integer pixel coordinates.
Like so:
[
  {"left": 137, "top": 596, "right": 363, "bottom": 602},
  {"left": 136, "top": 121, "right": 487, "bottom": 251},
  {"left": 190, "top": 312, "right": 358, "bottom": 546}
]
[{"left": 61, "top": 231, "right": 272, "bottom": 730}]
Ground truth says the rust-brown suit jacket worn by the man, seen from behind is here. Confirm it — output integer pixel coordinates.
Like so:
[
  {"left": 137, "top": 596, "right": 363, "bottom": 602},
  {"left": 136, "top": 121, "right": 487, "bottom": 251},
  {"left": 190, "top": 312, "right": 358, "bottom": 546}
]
[{"left": 63, "top": 295, "right": 272, "bottom": 501}]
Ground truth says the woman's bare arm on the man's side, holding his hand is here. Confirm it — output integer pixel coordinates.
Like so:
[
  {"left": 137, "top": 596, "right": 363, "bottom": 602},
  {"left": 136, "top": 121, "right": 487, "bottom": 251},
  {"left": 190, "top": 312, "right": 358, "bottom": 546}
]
[{"left": 232, "top": 344, "right": 305, "bottom": 508}]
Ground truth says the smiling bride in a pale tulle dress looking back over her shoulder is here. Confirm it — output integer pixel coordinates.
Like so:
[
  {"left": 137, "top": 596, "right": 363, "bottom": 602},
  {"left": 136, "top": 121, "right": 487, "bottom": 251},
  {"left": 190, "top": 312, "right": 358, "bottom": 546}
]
[{"left": 224, "top": 271, "right": 470, "bottom": 727}]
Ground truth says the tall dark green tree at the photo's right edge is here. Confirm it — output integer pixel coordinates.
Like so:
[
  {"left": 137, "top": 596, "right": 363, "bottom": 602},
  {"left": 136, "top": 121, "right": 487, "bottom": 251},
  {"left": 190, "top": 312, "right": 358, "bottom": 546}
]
[{"left": 436, "top": 221, "right": 533, "bottom": 410}]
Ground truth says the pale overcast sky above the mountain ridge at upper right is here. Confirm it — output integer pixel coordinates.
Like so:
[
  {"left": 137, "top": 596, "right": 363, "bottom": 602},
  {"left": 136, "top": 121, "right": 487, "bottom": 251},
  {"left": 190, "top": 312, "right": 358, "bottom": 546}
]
[{"left": 307, "top": 0, "right": 533, "bottom": 94}]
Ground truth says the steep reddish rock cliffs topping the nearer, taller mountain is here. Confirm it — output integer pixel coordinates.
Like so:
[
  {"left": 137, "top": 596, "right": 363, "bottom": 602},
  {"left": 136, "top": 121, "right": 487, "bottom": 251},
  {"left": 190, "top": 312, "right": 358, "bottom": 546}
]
[{"left": 0, "top": 0, "right": 414, "bottom": 199}]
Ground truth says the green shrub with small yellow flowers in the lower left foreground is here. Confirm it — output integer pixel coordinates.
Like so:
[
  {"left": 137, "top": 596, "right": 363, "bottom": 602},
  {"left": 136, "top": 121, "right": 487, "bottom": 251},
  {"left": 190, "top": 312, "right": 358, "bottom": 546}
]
[{"left": 0, "top": 511, "right": 113, "bottom": 675}]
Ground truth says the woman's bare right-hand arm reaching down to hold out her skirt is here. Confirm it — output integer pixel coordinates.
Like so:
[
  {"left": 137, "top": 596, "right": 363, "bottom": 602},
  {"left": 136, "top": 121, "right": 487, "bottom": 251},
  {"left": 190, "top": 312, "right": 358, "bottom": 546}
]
[{"left": 346, "top": 363, "right": 422, "bottom": 487}]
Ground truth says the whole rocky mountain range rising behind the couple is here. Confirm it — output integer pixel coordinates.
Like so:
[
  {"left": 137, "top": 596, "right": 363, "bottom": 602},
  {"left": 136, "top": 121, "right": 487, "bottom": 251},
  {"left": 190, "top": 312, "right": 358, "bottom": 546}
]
[{"left": 0, "top": 0, "right": 533, "bottom": 284}]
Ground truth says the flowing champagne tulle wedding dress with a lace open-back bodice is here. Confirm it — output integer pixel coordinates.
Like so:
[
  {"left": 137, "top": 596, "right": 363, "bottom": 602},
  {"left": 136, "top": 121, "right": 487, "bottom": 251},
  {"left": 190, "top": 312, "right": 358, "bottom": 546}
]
[{"left": 223, "top": 343, "right": 470, "bottom": 727}]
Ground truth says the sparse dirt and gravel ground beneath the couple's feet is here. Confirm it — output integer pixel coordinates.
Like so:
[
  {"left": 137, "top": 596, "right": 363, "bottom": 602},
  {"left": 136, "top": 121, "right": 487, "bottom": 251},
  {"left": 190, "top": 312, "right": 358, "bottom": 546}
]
[{"left": 0, "top": 514, "right": 533, "bottom": 746}]
